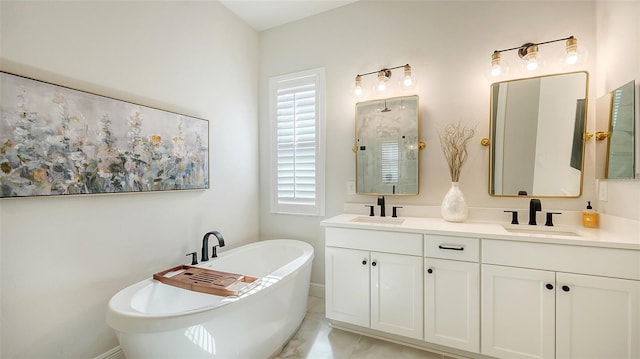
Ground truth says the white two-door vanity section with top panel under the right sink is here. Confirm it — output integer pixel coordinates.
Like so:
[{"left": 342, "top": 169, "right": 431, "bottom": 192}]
[{"left": 481, "top": 239, "right": 640, "bottom": 359}]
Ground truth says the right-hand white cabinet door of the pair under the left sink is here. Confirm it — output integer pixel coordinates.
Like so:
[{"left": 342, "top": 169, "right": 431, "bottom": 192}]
[{"left": 371, "top": 252, "right": 423, "bottom": 339}]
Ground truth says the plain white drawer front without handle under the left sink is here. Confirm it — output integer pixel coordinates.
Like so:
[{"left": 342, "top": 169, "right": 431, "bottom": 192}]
[{"left": 325, "top": 227, "right": 422, "bottom": 256}]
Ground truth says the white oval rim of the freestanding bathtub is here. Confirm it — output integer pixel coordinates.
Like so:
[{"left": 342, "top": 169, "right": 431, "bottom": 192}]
[{"left": 106, "top": 239, "right": 314, "bottom": 334}]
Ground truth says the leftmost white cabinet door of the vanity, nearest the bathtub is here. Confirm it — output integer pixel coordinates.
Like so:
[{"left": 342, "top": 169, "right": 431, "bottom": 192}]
[{"left": 325, "top": 247, "right": 370, "bottom": 327}]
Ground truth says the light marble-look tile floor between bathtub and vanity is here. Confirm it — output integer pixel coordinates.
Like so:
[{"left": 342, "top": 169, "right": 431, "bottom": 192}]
[{"left": 275, "top": 297, "right": 460, "bottom": 359}]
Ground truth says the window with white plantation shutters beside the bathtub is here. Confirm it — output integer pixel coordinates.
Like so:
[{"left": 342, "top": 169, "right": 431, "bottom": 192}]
[{"left": 269, "top": 69, "right": 324, "bottom": 215}]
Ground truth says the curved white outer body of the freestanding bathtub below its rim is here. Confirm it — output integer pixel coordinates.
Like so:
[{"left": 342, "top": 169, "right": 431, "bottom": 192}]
[{"left": 107, "top": 240, "right": 313, "bottom": 359}]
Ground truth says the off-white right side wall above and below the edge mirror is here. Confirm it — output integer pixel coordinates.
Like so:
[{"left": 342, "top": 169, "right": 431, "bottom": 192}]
[{"left": 596, "top": 0, "right": 640, "bottom": 220}]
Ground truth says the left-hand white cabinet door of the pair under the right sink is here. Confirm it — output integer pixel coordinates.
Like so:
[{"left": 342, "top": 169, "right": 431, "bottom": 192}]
[{"left": 481, "top": 264, "right": 555, "bottom": 359}]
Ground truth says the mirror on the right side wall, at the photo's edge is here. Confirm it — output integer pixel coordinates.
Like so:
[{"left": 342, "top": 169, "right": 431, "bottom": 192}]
[{"left": 596, "top": 81, "right": 636, "bottom": 179}]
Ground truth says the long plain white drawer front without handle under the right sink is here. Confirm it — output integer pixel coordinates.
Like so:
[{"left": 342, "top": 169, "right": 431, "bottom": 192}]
[{"left": 482, "top": 239, "right": 640, "bottom": 280}]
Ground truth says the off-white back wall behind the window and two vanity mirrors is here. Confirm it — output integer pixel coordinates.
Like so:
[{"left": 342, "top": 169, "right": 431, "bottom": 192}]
[{"left": 260, "top": 0, "right": 595, "bottom": 283}]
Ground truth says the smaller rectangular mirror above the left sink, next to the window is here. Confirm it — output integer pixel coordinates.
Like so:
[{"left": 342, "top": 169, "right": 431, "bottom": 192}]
[{"left": 354, "top": 95, "right": 419, "bottom": 195}]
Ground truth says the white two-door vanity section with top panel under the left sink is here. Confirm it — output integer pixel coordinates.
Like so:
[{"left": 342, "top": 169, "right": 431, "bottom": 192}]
[{"left": 325, "top": 227, "right": 423, "bottom": 339}]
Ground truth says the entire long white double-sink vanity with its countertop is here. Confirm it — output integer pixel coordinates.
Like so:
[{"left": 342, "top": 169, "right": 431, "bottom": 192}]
[{"left": 323, "top": 214, "right": 640, "bottom": 359}]
